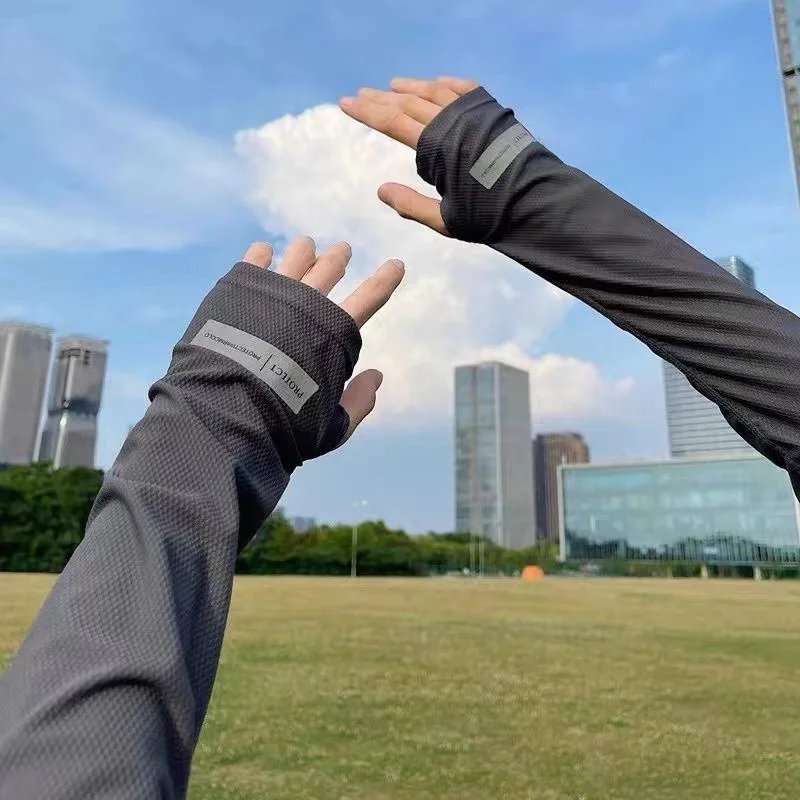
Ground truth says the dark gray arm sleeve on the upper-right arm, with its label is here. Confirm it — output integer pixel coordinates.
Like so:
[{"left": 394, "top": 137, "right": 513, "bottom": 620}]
[{"left": 417, "top": 88, "right": 800, "bottom": 494}]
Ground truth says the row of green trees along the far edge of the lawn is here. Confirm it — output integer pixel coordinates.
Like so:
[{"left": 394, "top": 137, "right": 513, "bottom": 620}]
[{"left": 0, "top": 464, "right": 556, "bottom": 576}]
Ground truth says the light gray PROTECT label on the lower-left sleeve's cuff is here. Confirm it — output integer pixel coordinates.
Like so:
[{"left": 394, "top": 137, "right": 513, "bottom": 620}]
[{"left": 191, "top": 319, "right": 319, "bottom": 414}]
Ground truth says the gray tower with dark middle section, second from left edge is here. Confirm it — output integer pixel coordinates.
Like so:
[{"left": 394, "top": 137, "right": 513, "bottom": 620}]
[{"left": 39, "top": 336, "right": 108, "bottom": 468}]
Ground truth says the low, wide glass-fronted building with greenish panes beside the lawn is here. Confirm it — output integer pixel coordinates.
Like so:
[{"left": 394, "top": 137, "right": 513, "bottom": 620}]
[{"left": 559, "top": 453, "right": 800, "bottom": 564}]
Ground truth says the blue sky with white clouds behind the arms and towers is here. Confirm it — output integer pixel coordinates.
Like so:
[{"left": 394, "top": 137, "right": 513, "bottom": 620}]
[{"left": 0, "top": 0, "right": 800, "bottom": 531}]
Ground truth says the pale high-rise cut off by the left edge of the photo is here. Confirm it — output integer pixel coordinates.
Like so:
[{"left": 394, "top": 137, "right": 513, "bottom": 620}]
[{"left": 0, "top": 322, "right": 52, "bottom": 464}]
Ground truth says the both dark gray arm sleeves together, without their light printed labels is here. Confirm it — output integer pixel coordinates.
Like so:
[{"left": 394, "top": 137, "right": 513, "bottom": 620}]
[{"left": 0, "top": 89, "right": 800, "bottom": 800}]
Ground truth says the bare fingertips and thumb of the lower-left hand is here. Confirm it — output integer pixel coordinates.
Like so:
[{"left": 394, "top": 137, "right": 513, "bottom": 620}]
[{"left": 242, "top": 236, "right": 405, "bottom": 443}]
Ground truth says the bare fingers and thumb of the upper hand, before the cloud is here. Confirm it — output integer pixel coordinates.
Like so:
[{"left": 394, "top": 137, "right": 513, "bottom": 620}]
[{"left": 339, "top": 78, "right": 478, "bottom": 236}]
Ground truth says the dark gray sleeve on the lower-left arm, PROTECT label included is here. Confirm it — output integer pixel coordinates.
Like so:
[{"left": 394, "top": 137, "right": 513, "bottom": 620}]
[{"left": 0, "top": 263, "right": 361, "bottom": 800}]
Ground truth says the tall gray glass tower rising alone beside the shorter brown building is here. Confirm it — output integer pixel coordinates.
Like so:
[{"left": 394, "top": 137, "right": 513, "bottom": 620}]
[{"left": 455, "top": 362, "right": 536, "bottom": 548}]
